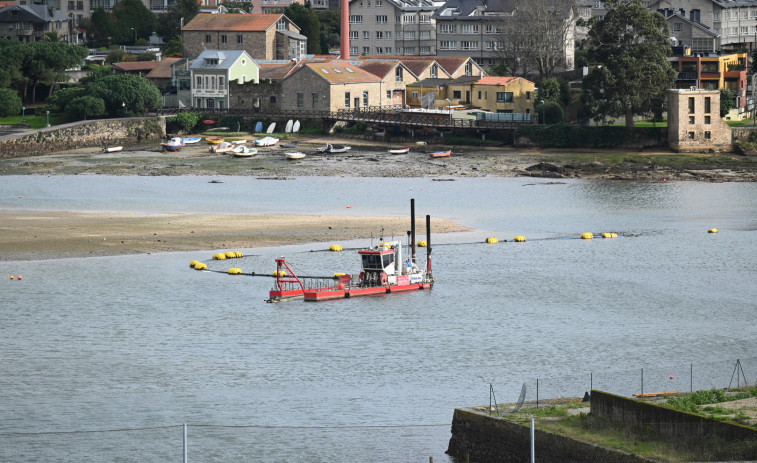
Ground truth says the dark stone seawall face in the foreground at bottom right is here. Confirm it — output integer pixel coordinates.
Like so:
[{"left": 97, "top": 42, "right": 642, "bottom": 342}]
[{"left": 447, "top": 408, "right": 652, "bottom": 463}]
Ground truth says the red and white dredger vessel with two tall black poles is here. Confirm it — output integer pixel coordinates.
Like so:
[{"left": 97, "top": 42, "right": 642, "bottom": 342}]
[{"left": 268, "top": 199, "right": 434, "bottom": 302}]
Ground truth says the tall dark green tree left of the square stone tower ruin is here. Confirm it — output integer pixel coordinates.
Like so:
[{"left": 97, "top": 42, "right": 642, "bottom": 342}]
[{"left": 582, "top": 0, "right": 676, "bottom": 127}]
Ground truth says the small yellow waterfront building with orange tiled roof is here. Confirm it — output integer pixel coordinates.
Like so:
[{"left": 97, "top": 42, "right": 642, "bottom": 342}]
[{"left": 471, "top": 76, "right": 536, "bottom": 114}]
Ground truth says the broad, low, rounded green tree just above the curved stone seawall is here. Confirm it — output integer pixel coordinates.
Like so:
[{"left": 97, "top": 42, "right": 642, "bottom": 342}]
[{"left": 87, "top": 74, "right": 163, "bottom": 117}]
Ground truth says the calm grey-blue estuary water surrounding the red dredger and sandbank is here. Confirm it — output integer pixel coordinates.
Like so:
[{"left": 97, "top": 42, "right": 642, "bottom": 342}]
[{"left": 0, "top": 175, "right": 757, "bottom": 463}]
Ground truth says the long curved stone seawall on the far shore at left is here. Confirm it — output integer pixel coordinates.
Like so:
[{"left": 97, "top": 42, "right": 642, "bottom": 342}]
[{"left": 0, "top": 117, "right": 166, "bottom": 158}]
